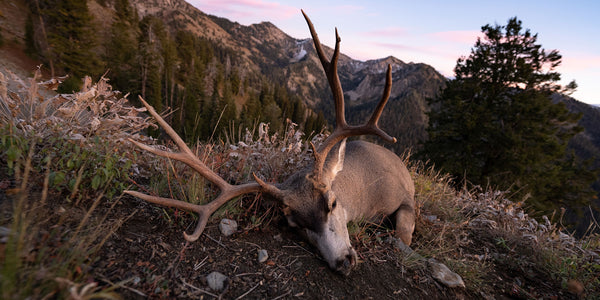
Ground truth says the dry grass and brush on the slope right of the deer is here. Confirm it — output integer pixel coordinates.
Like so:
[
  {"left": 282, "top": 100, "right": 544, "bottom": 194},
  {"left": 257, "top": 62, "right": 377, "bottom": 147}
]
[{"left": 411, "top": 158, "right": 600, "bottom": 298}]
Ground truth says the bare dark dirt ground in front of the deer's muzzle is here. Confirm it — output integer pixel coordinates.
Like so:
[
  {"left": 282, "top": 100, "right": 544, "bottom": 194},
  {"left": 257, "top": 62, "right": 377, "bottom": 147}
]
[{"left": 93, "top": 199, "right": 479, "bottom": 299}]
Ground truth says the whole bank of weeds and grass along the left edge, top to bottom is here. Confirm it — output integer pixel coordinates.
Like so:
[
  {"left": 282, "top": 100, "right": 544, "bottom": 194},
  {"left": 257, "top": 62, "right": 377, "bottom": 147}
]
[{"left": 0, "top": 70, "right": 151, "bottom": 299}]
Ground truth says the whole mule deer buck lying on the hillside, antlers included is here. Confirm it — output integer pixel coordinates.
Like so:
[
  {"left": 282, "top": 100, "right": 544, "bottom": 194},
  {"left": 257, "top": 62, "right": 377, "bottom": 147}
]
[{"left": 126, "top": 11, "right": 415, "bottom": 275}]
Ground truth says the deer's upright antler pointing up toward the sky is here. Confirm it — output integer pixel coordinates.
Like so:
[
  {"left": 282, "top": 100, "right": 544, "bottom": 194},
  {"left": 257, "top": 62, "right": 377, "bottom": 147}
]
[{"left": 302, "top": 10, "right": 396, "bottom": 180}]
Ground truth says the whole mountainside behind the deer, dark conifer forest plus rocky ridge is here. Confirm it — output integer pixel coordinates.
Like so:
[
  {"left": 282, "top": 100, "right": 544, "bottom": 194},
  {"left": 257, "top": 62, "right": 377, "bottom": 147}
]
[{"left": 0, "top": 0, "right": 445, "bottom": 151}]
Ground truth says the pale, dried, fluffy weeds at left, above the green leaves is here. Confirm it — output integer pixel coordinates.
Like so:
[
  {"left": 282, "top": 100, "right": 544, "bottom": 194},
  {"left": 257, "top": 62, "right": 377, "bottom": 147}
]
[{"left": 0, "top": 69, "right": 153, "bottom": 144}]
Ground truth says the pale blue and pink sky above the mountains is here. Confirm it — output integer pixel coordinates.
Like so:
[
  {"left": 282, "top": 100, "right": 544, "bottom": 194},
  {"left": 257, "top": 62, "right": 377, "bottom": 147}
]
[{"left": 186, "top": 0, "right": 600, "bottom": 104}]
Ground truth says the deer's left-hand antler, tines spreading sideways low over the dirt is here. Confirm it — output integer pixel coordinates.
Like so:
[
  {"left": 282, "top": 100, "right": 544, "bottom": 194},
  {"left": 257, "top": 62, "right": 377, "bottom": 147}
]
[{"left": 125, "top": 97, "right": 262, "bottom": 242}]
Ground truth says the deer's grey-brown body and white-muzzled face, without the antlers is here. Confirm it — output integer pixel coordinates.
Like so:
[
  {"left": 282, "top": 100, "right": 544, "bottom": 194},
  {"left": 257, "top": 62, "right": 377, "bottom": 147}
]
[{"left": 274, "top": 141, "right": 415, "bottom": 275}]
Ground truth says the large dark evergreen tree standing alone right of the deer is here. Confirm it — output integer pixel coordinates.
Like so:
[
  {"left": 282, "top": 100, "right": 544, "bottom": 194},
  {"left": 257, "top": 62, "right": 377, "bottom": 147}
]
[{"left": 421, "top": 18, "right": 591, "bottom": 211}]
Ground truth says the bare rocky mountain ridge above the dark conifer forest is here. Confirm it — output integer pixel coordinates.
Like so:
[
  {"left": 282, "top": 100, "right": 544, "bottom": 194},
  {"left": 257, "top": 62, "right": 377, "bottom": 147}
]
[{"left": 125, "top": 0, "right": 446, "bottom": 150}]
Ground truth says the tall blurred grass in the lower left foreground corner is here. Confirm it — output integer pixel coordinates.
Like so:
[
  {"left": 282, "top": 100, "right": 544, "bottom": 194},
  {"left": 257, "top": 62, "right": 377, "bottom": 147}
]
[{"left": 0, "top": 137, "right": 126, "bottom": 299}]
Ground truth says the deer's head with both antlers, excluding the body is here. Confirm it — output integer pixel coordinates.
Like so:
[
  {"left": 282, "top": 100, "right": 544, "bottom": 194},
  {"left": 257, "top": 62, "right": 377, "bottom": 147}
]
[{"left": 125, "top": 11, "right": 396, "bottom": 275}]
